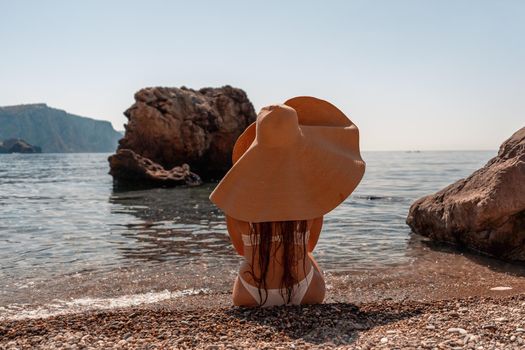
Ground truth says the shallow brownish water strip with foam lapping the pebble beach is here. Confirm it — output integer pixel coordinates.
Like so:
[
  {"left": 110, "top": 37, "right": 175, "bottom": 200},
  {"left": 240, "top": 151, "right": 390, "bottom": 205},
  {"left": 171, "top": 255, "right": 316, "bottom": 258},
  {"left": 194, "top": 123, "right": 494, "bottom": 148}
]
[{"left": 5, "top": 237, "right": 525, "bottom": 308}]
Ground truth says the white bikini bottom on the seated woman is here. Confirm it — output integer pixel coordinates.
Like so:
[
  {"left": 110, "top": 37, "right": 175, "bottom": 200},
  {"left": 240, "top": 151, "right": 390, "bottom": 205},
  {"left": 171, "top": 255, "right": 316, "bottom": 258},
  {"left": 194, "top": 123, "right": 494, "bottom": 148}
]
[{"left": 239, "top": 266, "right": 314, "bottom": 307}]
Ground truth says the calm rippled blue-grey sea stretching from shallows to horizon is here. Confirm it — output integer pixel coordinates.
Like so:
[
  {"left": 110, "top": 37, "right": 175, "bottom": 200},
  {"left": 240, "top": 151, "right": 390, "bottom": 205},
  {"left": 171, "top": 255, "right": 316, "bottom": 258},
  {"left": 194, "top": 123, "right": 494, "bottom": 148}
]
[{"left": 0, "top": 151, "right": 496, "bottom": 280}]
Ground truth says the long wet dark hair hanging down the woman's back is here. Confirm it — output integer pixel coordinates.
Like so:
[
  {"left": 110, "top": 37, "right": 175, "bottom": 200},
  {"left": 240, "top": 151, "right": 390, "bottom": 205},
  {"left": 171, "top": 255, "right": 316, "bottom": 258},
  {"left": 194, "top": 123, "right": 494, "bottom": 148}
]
[{"left": 245, "top": 220, "right": 307, "bottom": 304}]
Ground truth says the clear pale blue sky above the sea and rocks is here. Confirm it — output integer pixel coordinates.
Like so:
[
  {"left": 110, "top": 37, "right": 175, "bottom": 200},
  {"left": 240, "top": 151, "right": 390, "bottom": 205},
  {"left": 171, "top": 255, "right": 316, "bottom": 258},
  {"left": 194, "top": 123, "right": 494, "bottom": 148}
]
[{"left": 0, "top": 0, "right": 525, "bottom": 150}]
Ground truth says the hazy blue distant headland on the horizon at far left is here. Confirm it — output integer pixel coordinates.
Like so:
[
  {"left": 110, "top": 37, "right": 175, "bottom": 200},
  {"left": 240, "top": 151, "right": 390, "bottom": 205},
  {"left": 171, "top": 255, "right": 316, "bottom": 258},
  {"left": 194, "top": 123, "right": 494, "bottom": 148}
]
[{"left": 0, "top": 103, "right": 122, "bottom": 153}]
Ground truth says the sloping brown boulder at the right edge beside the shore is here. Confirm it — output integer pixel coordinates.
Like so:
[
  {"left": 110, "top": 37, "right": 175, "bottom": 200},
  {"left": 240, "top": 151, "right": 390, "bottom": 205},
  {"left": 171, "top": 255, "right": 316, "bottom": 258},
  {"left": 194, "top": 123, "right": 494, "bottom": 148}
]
[{"left": 407, "top": 127, "right": 525, "bottom": 261}]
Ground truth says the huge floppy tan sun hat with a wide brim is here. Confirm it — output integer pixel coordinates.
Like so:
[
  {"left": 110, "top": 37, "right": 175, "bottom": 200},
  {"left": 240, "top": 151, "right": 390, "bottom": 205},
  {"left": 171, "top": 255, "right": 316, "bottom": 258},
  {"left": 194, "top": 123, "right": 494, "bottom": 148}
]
[{"left": 210, "top": 96, "right": 365, "bottom": 222}]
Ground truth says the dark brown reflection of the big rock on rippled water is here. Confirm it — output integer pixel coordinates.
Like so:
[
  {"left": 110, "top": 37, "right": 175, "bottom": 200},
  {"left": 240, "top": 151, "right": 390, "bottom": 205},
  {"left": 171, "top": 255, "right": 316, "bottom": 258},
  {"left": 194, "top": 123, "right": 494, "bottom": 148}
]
[{"left": 109, "top": 184, "right": 237, "bottom": 264}]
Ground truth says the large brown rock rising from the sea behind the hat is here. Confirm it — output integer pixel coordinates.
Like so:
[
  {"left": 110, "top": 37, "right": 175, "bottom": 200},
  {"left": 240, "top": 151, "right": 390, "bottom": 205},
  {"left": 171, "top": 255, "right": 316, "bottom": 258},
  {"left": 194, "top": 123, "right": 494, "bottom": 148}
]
[{"left": 108, "top": 86, "right": 256, "bottom": 184}]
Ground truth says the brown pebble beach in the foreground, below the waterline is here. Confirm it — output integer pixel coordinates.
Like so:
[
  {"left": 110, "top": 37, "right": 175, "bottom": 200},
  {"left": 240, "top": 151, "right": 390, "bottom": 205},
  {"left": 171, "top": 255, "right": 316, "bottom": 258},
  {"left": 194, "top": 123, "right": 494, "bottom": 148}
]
[{"left": 0, "top": 288, "right": 525, "bottom": 349}]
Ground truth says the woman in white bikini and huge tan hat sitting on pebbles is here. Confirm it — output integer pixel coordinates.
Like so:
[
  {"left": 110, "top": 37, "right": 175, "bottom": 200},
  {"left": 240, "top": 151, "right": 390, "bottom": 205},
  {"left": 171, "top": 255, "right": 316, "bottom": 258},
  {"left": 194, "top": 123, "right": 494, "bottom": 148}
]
[{"left": 210, "top": 96, "right": 365, "bottom": 306}]
